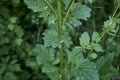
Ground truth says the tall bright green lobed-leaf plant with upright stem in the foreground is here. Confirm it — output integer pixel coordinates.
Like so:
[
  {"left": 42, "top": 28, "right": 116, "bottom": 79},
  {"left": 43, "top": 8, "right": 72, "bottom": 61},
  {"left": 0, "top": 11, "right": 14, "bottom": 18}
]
[{"left": 24, "top": 0, "right": 120, "bottom": 80}]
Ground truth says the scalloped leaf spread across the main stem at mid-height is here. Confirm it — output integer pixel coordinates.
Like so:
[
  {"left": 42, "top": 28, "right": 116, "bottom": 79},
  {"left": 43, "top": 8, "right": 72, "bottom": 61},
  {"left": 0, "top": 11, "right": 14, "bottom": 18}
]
[{"left": 43, "top": 29, "right": 72, "bottom": 48}]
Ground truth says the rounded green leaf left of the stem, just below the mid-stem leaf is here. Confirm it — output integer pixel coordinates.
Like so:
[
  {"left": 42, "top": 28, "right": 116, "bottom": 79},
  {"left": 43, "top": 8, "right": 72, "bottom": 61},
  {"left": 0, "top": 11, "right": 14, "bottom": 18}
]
[{"left": 33, "top": 44, "right": 55, "bottom": 65}]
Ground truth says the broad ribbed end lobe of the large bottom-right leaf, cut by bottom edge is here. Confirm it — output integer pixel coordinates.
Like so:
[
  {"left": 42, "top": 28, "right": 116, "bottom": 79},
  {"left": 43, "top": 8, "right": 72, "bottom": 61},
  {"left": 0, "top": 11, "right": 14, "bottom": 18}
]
[{"left": 73, "top": 59, "right": 99, "bottom": 80}]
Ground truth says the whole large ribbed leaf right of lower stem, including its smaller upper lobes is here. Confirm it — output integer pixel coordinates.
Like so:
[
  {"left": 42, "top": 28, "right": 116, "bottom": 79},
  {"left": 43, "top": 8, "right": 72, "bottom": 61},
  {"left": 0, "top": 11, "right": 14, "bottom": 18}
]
[{"left": 66, "top": 47, "right": 99, "bottom": 80}]
